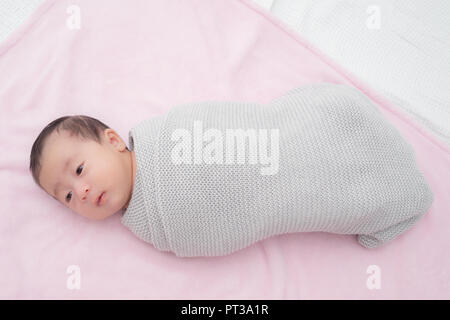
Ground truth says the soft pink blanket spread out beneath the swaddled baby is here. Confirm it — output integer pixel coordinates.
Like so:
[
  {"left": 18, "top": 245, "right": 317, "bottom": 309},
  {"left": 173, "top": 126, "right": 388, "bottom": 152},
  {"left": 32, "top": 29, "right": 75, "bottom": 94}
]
[{"left": 0, "top": 0, "right": 450, "bottom": 299}]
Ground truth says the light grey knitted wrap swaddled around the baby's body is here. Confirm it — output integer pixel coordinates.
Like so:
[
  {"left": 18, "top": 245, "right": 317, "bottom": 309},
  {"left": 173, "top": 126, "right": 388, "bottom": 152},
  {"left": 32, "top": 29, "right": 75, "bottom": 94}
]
[{"left": 122, "top": 83, "right": 433, "bottom": 257}]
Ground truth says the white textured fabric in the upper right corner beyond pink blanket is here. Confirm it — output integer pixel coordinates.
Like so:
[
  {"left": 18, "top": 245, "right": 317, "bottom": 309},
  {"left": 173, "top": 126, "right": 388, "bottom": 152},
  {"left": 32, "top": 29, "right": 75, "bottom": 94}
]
[{"left": 253, "top": 0, "right": 450, "bottom": 145}]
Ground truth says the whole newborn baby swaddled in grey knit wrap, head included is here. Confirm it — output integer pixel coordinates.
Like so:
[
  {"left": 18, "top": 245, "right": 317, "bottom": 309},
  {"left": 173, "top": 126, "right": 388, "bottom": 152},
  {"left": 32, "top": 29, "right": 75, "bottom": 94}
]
[{"left": 30, "top": 83, "right": 433, "bottom": 257}]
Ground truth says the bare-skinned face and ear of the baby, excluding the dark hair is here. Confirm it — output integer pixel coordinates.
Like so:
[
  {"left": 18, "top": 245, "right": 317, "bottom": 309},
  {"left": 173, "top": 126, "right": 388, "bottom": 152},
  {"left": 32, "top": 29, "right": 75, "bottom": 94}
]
[{"left": 39, "top": 129, "right": 136, "bottom": 220}]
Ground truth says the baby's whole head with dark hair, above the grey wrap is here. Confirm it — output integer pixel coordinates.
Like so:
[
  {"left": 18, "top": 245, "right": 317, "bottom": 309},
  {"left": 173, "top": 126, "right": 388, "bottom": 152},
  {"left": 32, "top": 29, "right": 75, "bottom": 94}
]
[{"left": 30, "top": 115, "right": 136, "bottom": 220}]
